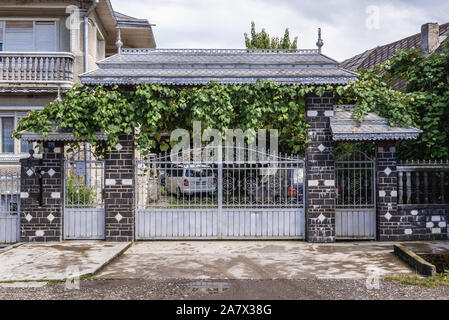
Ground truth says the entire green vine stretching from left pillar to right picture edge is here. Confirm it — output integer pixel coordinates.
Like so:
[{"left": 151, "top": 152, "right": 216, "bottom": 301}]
[{"left": 13, "top": 43, "right": 449, "bottom": 159}]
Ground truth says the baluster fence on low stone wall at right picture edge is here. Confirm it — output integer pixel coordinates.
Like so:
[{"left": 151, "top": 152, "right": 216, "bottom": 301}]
[{"left": 397, "top": 161, "right": 449, "bottom": 204}]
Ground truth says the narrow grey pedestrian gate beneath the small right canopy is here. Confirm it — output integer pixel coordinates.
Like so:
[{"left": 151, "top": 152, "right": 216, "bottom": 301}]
[{"left": 335, "top": 151, "right": 376, "bottom": 240}]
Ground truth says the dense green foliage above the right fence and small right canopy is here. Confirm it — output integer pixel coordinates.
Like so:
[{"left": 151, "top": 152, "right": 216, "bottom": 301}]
[{"left": 337, "top": 43, "right": 449, "bottom": 160}]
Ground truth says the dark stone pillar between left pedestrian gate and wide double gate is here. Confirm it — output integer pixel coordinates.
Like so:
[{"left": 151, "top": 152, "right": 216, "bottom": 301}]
[{"left": 105, "top": 135, "right": 134, "bottom": 242}]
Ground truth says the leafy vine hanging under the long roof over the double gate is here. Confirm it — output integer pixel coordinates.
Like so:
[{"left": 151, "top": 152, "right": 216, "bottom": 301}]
[{"left": 14, "top": 81, "right": 316, "bottom": 153}]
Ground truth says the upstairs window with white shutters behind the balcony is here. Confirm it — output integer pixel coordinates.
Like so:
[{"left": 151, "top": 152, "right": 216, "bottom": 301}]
[{"left": 0, "top": 20, "right": 56, "bottom": 52}]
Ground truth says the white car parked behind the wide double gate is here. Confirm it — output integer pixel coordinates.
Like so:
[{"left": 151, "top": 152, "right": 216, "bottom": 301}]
[{"left": 165, "top": 165, "right": 217, "bottom": 197}]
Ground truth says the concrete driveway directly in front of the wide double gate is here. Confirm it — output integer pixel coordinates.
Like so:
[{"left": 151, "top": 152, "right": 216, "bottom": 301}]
[{"left": 97, "top": 241, "right": 413, "bottom": 280}]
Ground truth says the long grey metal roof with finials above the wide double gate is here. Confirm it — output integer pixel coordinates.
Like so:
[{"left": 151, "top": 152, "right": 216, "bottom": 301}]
[{"left": 81, "top": 49, "right": 358, "bottom": 85}]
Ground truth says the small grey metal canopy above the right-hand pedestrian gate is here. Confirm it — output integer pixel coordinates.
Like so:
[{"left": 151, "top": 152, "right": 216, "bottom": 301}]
[{"left": 330, "top": 106, "right": 422, "bottom": 141}]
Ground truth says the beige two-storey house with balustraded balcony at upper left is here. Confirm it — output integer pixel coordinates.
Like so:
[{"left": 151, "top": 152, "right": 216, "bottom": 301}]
[{"left": 0, "top": 0, "right": 156, "bottom": 168}]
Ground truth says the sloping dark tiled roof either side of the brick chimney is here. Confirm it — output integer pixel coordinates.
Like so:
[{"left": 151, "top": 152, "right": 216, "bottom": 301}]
[{"left": 341, "top": 22, "right": 449, "bottom": 70}]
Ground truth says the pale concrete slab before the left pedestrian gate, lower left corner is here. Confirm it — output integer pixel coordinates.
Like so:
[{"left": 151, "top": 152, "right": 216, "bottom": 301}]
[{"left": 0, "top": 241, "right": 130, "bottom": 282}]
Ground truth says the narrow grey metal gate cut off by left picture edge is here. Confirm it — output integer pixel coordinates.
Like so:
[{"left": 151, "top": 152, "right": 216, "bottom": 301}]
[{"left": 0, "top": 167, "right": 20, "bottom": 243}]
